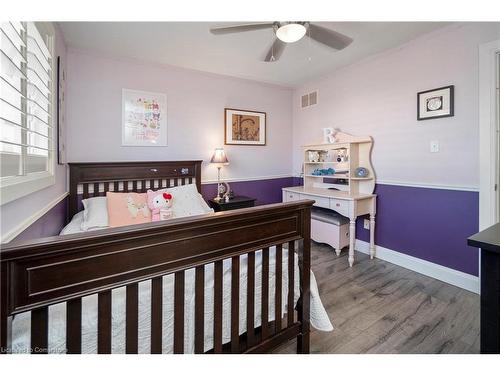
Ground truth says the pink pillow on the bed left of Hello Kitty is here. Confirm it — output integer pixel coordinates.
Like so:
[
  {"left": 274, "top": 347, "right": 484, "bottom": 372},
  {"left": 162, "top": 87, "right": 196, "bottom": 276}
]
[{"left": 106, "top": 191, "right": 151, "bottom": 227}]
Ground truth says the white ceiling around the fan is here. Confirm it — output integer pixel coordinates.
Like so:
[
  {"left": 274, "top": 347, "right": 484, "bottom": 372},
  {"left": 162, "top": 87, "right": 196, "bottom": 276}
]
[{"left": 59, "top": 22, "right": 446, "bottom": 86}]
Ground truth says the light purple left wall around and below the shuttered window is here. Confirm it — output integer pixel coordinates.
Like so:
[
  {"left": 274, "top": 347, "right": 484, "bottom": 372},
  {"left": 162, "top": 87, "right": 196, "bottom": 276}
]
[{"left": 0, "top": 24, "right": 67, "bottom": 238}]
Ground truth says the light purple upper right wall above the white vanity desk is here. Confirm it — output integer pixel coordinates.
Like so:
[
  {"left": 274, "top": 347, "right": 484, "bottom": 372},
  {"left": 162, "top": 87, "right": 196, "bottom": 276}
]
[{"left": 293, "top": 22, "right": 500, "bottom": 190}]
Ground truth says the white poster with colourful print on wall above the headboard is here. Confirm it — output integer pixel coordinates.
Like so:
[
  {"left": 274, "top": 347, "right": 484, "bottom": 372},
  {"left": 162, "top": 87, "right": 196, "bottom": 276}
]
[{"left": 122, "top": 89, "right": 167, "bottom": 147}]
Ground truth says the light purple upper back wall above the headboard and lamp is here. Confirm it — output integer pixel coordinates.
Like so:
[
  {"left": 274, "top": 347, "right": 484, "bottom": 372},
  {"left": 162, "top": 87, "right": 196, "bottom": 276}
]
[{"left": 67, "top": 50, "right": 292, "bottom": 181}]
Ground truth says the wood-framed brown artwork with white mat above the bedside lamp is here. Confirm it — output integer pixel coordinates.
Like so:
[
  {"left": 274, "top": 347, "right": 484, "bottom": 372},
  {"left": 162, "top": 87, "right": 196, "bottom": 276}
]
[{"left": 224, "top": 108, "right": 267, "bottom": 146}]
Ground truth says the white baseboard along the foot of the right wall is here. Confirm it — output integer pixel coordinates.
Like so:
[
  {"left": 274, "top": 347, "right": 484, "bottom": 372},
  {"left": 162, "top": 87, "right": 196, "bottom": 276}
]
[{"left": 354, "top": 240, "right": 480, "bottom": 294}]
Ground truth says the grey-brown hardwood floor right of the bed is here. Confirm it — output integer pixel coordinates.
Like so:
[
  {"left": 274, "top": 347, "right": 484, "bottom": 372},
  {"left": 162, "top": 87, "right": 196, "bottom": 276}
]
[{"left": 274, "top": 242, "right": 479, "bottom": 353}]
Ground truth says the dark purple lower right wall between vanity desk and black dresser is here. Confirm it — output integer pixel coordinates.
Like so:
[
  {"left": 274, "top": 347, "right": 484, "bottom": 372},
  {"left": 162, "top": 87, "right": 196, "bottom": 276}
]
[{"left": 356, "top": 184, "right": 479, "bottom": 276}]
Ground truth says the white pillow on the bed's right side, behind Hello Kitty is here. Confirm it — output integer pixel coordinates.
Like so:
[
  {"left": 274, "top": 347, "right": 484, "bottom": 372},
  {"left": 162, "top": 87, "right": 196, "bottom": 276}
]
[{"left": 154, "top": 184, "right": 214, "bottom": 218}]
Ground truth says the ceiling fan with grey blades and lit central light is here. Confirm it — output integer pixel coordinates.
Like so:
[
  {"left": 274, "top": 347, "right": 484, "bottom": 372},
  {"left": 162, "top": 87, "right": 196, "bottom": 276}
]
[{"left": 210, "top": 21, "right": 353, "bottom": 62}]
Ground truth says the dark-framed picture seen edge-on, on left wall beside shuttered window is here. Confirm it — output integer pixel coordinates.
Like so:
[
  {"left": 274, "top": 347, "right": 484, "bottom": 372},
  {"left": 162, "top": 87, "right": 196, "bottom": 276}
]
[{"left": 56, "top": 56, "right": 66, "bottom": 165}]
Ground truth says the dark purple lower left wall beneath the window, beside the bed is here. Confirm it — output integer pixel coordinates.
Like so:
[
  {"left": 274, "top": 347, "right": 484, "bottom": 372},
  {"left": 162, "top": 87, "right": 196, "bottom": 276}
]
[{"left": 12, "top": 198, "right": 68, "bottom": 242}]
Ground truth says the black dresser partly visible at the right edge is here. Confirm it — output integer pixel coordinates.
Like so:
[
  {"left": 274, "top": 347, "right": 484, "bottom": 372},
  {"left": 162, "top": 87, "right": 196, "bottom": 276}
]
[{"left": 467, "top": 223, "right": 500, "bottom": 353}]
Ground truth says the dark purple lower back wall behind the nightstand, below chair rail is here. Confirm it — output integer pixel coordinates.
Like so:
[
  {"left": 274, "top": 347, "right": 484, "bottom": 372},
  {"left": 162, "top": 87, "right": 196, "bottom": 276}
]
[{"left": 201, "top": 177, "right": 295, "bottom": 205}]
